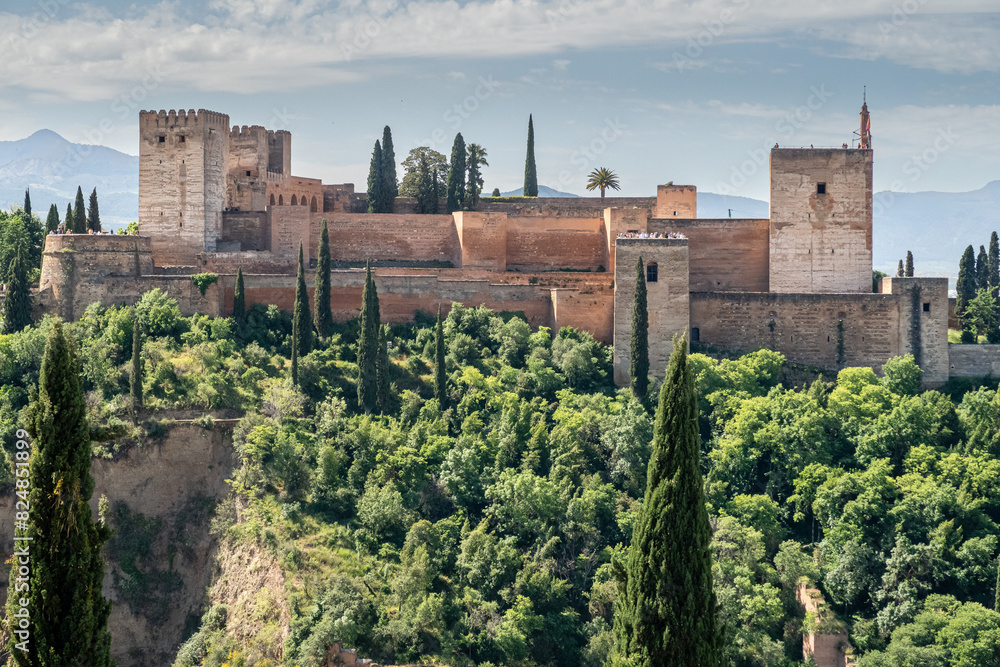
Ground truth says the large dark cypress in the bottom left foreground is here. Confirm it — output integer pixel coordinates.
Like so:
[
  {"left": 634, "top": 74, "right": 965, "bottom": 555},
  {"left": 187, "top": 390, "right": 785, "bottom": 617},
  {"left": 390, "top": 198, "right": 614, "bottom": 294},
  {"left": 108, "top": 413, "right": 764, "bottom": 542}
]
[{"left": 7, "top": 321, "right": 112, "bottom": 667}]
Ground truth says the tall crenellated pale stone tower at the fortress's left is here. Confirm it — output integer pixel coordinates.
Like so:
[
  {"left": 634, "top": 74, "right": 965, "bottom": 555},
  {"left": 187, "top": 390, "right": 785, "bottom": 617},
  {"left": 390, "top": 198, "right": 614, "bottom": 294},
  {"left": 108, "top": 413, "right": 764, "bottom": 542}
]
[{"left": 139, "top": 109, "right": 230, "bottom": 266}]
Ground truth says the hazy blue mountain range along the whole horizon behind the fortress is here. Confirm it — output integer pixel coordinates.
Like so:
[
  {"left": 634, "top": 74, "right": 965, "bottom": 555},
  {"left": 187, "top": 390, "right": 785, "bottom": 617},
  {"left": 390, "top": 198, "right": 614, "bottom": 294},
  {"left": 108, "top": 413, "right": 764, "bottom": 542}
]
[{"left": 0, "top": 130, "right": 1000, "bottom": 278}]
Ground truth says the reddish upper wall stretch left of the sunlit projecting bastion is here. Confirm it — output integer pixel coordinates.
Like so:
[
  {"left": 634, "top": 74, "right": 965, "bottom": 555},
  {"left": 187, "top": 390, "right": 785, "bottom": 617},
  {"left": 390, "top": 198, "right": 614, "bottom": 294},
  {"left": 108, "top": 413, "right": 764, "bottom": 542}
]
[{"left": 318, "top": 213, "right": 461, "bottom": 266}]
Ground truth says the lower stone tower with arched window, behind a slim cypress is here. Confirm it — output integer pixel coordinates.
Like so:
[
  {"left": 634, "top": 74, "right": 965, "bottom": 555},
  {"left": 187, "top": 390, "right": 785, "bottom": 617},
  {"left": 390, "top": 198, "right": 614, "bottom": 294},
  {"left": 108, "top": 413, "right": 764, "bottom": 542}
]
[{"left": 614, "top": 238, "right": 691, "bottom": 387}]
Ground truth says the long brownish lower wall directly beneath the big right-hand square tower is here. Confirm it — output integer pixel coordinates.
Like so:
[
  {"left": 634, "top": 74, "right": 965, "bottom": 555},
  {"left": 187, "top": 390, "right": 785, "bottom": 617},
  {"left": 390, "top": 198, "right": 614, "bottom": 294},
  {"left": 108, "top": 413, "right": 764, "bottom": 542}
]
[{"left": 691, "top": 292, "right": 908, "bottom": 370}]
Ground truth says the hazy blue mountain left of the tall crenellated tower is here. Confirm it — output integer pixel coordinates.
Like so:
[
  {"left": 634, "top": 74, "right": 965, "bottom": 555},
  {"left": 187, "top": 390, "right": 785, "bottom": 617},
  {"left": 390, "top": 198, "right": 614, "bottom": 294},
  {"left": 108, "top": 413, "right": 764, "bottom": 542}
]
[{"left": 0, "top": 130, "right": 139, "bottom": 228}]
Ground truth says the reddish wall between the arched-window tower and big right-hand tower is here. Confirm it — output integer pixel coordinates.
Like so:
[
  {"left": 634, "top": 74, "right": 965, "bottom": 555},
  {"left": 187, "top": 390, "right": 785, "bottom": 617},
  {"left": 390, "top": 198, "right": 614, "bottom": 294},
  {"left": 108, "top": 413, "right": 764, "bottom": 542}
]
[{"left": 649, "top": 218, "right": 770, "bottom": 292}]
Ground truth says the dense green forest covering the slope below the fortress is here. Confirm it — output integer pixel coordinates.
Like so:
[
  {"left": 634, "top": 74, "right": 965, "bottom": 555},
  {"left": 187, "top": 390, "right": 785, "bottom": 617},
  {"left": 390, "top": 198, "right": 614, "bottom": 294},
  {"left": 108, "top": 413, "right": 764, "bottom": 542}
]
[{"left": 0, "top": 290, "right": 1000, "bottom": 667}]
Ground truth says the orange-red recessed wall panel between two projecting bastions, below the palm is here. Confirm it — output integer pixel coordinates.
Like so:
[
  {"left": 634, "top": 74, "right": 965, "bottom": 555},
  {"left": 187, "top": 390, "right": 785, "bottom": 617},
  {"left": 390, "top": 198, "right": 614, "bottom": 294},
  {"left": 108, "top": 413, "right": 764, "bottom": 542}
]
[{"left": 506, "top": 218, "right": 607, "bottom": 271}]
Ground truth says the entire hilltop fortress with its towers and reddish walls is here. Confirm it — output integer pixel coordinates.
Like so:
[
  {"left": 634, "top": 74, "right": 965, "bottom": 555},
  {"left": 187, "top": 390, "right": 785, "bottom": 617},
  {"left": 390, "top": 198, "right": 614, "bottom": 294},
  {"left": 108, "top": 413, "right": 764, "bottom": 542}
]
[{"left": 39, "top": 107, "right": 1000, "bottom": 386}]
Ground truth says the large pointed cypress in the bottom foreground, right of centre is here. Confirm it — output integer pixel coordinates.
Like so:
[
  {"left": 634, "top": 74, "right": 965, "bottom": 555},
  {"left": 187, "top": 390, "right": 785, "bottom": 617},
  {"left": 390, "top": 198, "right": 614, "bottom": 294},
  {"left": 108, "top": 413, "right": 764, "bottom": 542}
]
[{"left": 611, "top": 338, "right": 721, "bottom": 667}]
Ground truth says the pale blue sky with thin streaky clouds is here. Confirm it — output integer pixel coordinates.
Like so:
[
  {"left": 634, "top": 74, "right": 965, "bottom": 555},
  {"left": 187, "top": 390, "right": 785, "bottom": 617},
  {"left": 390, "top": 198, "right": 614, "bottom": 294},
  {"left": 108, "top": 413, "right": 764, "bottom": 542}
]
[{"left": 0, "top": 0, "right": 1000, "bottom": 201}]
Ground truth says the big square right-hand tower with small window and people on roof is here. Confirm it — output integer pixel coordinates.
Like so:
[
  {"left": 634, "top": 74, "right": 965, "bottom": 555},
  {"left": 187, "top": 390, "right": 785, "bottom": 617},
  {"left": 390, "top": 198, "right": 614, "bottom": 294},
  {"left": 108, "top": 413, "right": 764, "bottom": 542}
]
[{"left": 768, "top": 148, "right": 872, "bottom": 293}]
